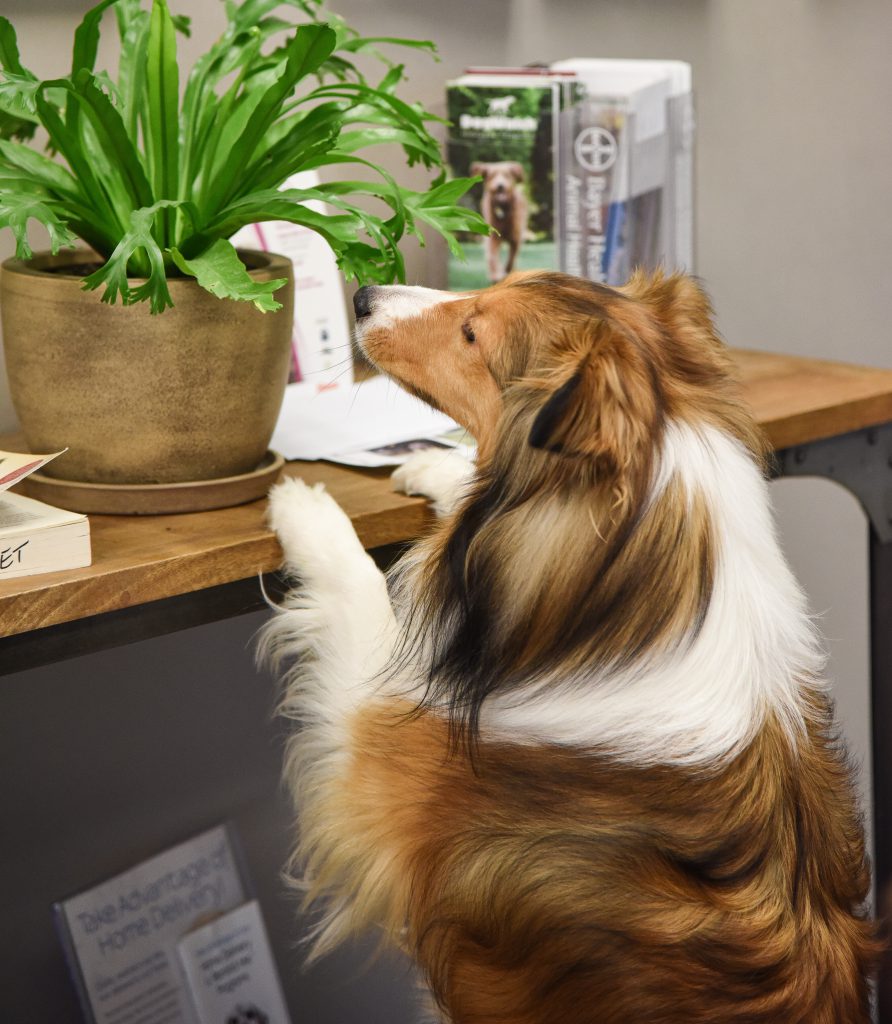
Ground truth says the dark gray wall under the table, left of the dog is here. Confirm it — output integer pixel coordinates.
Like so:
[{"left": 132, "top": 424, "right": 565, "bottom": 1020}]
[{"left": 0, "top": 614, "right": 419, "bottom": 1024}]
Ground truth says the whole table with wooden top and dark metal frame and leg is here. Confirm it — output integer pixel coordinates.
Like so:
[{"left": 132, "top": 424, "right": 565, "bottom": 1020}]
[{"left": 0, "top": 350, "right": 892, "bottom": 1024}]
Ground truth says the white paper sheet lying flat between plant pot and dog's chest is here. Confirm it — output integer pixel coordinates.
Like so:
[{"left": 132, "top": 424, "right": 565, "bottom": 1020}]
[{"left": 270, "top": 377, "right": 456, "bottom": 461}]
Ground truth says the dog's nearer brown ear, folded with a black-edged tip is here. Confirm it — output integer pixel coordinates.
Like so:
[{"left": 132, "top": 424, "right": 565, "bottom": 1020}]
[{"left": 529, "top": 321, "right": 662, "bottom": 471}]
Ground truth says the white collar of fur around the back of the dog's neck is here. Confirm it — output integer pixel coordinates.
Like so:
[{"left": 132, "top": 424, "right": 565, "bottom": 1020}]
[{"left": 481, "top": 423, "right": 824, "bottom": 765}]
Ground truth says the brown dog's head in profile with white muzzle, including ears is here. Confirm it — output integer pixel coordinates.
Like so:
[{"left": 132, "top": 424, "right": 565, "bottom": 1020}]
[{"left": 354, "top": 271, "right": 751, "bottom": 474}]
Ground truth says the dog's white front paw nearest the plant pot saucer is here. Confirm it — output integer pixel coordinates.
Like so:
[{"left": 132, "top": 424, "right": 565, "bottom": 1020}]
[{"left": 266, "top": 477, "right": 367, "bottom": 577}]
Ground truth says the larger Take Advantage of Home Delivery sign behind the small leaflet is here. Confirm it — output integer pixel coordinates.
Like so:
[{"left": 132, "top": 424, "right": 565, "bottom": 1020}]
[{"left": 53, "top": 825, "right": 249, "bottom": 1024}]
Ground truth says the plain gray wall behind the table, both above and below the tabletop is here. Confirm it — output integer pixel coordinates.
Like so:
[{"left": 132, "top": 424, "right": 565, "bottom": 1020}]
[{"left": 0, "top": 0, "right": 892, "bottom": 1024}]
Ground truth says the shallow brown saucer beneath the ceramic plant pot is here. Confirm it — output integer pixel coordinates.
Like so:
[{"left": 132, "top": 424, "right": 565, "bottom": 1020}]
[{"left": 20, "top": 451, "right": 285, "bottom": 515}]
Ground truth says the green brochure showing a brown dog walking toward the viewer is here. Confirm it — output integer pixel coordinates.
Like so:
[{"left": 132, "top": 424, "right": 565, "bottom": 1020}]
[{"left": 447, "top": 73, "right": 561, "bottom": 291}]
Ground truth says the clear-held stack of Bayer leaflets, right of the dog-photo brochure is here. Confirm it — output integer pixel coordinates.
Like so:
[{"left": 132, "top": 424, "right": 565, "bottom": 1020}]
[{"left": 553, "top": 58, "right": 693, "bottom": 285}]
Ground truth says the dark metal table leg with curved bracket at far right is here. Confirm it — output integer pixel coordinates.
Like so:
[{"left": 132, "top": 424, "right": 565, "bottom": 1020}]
[{"left": 775, "top": 423, "right": 892, "bottom": 1024}]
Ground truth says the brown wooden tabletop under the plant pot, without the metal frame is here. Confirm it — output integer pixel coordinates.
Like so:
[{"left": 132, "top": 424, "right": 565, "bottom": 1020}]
[{"left": 0, "top": 350, "right": 892, "bottom": 637}]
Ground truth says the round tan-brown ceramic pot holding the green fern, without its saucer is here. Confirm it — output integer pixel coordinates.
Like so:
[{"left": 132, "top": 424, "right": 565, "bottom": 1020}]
[{"left": 0, "top": 252, "right": 294, "bottom": 484}]
